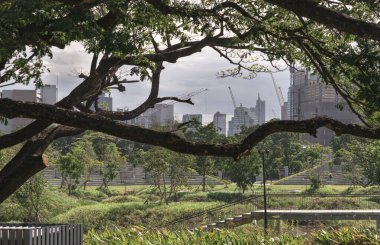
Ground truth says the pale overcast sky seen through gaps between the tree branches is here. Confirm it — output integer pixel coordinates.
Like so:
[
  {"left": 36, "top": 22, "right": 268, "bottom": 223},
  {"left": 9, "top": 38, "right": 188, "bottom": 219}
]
[{"left": 4, "top": 44, "right": 289, "bottom": 121}]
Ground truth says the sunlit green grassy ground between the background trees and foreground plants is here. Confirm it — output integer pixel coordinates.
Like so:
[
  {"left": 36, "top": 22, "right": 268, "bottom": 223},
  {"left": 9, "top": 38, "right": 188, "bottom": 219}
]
[{"left": 0, "top": 184, "right": 380, "bottom": 233}]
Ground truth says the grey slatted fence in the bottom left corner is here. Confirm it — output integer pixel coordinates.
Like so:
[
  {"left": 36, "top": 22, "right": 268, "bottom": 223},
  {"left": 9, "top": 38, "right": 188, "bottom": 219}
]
[{"left": 0, "top": 223, "right": 83, "bottom": 245}]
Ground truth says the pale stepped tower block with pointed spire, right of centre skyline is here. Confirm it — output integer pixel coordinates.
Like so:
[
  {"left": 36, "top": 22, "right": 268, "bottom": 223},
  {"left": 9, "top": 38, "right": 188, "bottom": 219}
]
[{"left": 228, "top": 94, "right": 265, "bottom": 136}]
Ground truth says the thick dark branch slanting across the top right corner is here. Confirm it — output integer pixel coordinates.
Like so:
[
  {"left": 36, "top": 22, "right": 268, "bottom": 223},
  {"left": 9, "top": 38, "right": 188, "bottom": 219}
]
[{"left": 265, "top": 0, "right": 380, "bottom": 41}]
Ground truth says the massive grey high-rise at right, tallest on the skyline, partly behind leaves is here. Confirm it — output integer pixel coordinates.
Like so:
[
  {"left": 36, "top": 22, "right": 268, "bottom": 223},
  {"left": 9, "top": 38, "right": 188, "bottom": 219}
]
[{"left": 288, "top": 68, "right": 359, "bottom": 146}]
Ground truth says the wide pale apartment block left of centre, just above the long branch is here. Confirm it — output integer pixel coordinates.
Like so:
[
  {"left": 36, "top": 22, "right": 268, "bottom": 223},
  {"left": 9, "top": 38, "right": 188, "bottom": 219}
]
[{"left": 128, "top": 104, "right": 174, "bottom": 128}]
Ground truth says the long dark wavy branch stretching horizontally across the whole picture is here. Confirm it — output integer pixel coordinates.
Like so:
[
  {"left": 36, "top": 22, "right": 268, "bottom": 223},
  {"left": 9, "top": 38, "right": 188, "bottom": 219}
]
[{"left": 0, "top": 99, "right": 380, "bottom": 159}]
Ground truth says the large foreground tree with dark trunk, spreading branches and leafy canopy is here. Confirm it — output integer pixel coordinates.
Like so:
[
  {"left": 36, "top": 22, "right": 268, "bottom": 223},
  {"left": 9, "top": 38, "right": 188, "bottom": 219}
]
[{"left": 0, "top": 0, "right": 380, "bottom": 202}]
